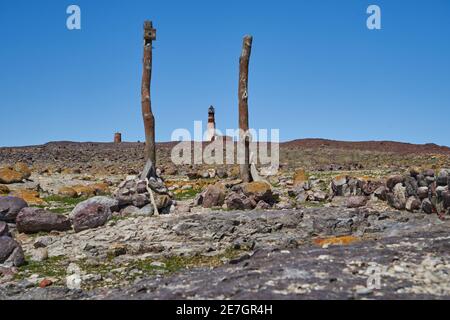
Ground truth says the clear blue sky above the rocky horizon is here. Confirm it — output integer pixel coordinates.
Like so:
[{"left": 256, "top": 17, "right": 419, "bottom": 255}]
[{"left": 0, "top": 0, "right": 450, "bottom": 146}]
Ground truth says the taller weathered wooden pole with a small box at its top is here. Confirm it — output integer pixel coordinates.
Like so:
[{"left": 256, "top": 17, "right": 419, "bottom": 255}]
[{"left": 141, "top": 21, "right": 156, "bottom": 166}]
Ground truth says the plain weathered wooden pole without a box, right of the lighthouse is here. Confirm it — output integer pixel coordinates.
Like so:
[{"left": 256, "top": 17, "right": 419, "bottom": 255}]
[{"left": 238, "top": 36, "right": 253, "bottom": 182}]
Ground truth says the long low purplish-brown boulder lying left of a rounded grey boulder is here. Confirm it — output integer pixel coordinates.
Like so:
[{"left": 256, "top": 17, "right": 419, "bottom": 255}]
[{"left": 16, "top": 208, "right": 72, "bottom": 234}]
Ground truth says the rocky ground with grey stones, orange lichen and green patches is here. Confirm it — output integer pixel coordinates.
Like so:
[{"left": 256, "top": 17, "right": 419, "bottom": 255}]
[{"left": 0, "top": 139, "right": 450, "bottom": 299}]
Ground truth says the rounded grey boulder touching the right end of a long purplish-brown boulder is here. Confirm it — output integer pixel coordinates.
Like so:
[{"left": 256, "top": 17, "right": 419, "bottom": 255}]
[{"left": 71, "top": 203, "right": 112, "bottom": 232}]
